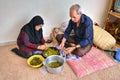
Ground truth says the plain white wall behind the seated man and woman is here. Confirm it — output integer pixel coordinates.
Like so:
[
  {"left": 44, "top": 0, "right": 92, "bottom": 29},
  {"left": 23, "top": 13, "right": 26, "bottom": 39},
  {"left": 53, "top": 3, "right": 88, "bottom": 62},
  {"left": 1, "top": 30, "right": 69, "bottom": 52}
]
[{"left": 0, "top": 0, "right": 109, "bottom": 43}]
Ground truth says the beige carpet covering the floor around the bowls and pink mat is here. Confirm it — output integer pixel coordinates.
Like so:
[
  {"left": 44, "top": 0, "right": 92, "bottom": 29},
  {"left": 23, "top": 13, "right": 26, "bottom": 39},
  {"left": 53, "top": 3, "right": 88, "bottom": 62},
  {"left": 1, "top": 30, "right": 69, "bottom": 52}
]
[{"left": 0, "top": 44, "right": 120, "bottom": 80}]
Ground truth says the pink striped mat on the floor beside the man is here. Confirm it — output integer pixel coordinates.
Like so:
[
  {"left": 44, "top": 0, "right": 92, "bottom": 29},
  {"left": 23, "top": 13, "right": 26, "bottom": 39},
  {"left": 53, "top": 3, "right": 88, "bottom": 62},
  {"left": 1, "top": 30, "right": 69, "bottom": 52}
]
[{"left": 67, "top": 47, "right": 115, "bottom": 77}]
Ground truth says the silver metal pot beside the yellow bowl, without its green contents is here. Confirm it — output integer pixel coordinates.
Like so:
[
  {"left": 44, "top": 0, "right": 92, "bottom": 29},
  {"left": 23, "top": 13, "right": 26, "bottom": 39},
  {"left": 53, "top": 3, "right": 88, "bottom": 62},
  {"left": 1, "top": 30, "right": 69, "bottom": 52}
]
[{"left": 43, "top": 55, "right": 65, "bottom": 74}]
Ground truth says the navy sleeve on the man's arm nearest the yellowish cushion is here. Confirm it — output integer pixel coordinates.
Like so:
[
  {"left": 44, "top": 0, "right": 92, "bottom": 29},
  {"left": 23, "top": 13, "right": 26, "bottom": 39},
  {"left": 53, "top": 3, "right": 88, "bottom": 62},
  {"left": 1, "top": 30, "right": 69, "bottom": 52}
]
[{"left": 79, "top": 20, "right": 93, "bottom": 47}]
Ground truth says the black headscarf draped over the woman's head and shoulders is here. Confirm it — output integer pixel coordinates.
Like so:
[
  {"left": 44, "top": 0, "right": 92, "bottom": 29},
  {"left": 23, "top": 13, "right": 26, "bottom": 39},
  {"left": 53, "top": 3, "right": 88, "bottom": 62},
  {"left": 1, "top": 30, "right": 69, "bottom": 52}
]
[{"left": 21, "top": 16, "right": 44, "bottom": 44}]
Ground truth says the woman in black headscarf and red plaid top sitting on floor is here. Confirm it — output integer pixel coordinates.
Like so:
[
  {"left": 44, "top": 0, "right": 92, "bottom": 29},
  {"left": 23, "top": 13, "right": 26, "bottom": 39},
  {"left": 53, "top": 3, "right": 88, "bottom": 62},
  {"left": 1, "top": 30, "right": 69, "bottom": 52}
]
[{"left": 17, "top": 16, "right": 47, "bottom": 58}]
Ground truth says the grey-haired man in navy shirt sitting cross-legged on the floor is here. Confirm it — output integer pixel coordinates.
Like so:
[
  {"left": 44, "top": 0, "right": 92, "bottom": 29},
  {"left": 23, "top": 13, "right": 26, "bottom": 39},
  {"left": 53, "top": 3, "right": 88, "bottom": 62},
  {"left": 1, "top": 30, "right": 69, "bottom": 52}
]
[{"left": 56, "top": 4, "right": 93, "bottom": 57}]
